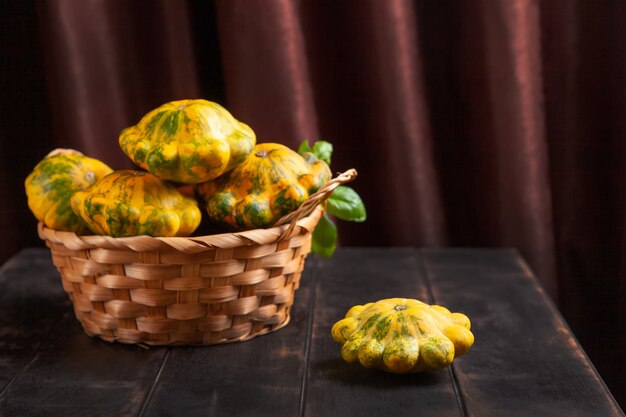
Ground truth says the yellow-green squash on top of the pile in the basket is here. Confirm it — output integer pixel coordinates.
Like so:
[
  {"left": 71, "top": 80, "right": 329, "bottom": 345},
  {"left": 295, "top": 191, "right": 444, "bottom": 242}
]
[{"left": 119, "top": 99, "right": 256, "bottom": 184}]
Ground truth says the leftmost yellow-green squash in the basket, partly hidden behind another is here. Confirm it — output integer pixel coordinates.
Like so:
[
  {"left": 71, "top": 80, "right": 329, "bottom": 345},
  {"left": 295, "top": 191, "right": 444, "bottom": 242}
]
[{"left": 24, "top": 149, "right": 112, "bottom": 234}]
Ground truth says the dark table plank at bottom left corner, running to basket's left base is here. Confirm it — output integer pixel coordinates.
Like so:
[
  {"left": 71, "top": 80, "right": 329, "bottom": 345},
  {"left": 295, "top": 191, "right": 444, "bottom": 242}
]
[{"left": 0, "top": 249, "right": 167, "bottom": 417}]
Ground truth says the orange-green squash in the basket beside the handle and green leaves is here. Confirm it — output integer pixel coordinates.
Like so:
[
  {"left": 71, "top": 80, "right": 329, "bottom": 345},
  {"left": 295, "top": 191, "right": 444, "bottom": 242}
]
[{"left": 197, "top": 143, "right": 331, "bottom": 230}]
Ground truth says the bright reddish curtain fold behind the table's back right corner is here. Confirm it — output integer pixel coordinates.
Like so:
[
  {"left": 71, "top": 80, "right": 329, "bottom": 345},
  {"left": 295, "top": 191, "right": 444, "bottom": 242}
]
[{"left": 475, "top": 0, "right": 557, "bottom": 297}]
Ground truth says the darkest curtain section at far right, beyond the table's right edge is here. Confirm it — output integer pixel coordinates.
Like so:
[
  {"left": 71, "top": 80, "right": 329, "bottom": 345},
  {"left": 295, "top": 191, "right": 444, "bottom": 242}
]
[{"left": 541, "top": 1, "right": 626, "bottom": 407}]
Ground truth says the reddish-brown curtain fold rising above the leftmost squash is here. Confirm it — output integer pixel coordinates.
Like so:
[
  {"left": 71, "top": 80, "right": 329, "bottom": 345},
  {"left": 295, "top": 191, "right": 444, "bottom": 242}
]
[{"left": 41, "top": 0, "right": 131, "bottom": 162}]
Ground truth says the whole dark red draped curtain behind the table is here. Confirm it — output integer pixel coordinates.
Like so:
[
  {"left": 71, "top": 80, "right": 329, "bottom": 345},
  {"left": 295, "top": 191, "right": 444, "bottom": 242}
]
[{"left": 0, "top": 0, "right": 626, "bottom": 404}]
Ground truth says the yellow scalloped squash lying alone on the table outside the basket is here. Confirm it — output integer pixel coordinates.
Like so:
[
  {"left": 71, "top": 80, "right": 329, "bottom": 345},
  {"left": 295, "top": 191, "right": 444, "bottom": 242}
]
[{"left": 331, "top": 298, "right": 474, "bottom": 373}]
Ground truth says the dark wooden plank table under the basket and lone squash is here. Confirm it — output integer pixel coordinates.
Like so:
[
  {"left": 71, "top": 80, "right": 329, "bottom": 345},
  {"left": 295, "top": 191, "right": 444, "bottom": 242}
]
[{"left": 0, "top": 249, "right": 624, "bottom": 417}]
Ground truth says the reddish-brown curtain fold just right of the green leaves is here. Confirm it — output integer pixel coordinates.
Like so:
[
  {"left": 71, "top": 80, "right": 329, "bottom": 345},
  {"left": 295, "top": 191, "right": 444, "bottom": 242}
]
[{"left": 342, "top": 0, "right": 447, "bottom": 246}]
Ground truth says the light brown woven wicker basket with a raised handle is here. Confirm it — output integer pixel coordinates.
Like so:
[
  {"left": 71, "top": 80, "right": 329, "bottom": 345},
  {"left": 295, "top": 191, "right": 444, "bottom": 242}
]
[{"left": 38, "top": 170, "right": 356, "bottom": 345}]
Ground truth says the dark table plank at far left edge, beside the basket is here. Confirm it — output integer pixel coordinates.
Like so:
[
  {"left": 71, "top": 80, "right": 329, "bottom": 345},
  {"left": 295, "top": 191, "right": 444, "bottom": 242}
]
[{"left": 0, "top": 249, "right": 70, "bottom": 397}]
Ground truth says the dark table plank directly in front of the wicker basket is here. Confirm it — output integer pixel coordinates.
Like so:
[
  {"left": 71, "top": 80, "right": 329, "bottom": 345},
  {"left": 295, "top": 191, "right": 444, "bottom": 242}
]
[{"left": 143, "top": 257, "right": 317, "bottom": 416}]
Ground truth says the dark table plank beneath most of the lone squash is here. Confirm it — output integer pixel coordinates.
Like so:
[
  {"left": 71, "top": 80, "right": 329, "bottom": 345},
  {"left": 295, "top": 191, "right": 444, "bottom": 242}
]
[{"left": 303, "top": 249, "right": 462, "bottom": 417}]
